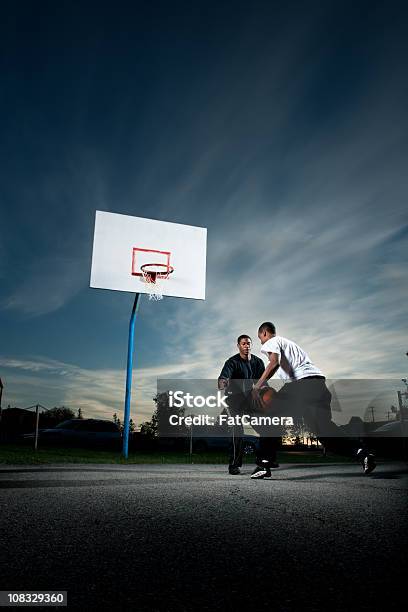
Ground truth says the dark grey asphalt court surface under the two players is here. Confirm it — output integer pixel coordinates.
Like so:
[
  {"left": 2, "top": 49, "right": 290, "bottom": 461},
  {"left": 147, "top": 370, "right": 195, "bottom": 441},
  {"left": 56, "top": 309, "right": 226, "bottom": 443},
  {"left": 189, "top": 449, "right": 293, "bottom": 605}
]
[{"left": 0, "top": 462, "right": 408, "bottom": 611}]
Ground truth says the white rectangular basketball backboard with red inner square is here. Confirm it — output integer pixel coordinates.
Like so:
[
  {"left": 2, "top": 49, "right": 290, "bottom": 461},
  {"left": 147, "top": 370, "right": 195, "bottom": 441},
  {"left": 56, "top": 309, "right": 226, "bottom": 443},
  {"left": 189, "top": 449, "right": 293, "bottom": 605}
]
[{"left": 90, "top": 210, "right": 207, "bottom": 300}]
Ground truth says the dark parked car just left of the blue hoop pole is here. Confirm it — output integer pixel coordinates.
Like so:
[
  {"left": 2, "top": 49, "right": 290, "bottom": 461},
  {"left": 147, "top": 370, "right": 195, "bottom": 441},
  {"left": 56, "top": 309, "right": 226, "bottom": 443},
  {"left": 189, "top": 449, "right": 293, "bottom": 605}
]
[{"left": 23, "top": 419, "right": 122, "bottom": 449}]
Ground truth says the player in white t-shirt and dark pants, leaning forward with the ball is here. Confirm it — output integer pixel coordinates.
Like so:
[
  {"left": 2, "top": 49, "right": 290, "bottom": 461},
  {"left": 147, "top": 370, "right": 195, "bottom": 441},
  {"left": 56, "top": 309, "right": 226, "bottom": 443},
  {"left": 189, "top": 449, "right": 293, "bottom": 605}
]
[{"left": 251, "top": 321, "right": 376, "bottom": 478}]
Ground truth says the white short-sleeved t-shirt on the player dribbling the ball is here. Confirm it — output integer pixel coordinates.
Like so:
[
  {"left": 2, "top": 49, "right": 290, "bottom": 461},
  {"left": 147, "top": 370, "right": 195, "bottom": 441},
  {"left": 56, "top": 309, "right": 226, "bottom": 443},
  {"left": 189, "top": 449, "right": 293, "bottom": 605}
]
[{"left": 261, "top": 336, "right": 323, "bottom": 380}]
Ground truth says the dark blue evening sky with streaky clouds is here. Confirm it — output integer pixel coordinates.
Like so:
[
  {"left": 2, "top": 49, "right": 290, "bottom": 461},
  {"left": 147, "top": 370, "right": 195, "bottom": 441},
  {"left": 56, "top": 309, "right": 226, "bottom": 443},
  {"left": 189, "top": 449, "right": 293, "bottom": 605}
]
[{"left": 0, "top": 2, "right": 408, "bottom": 420}]
